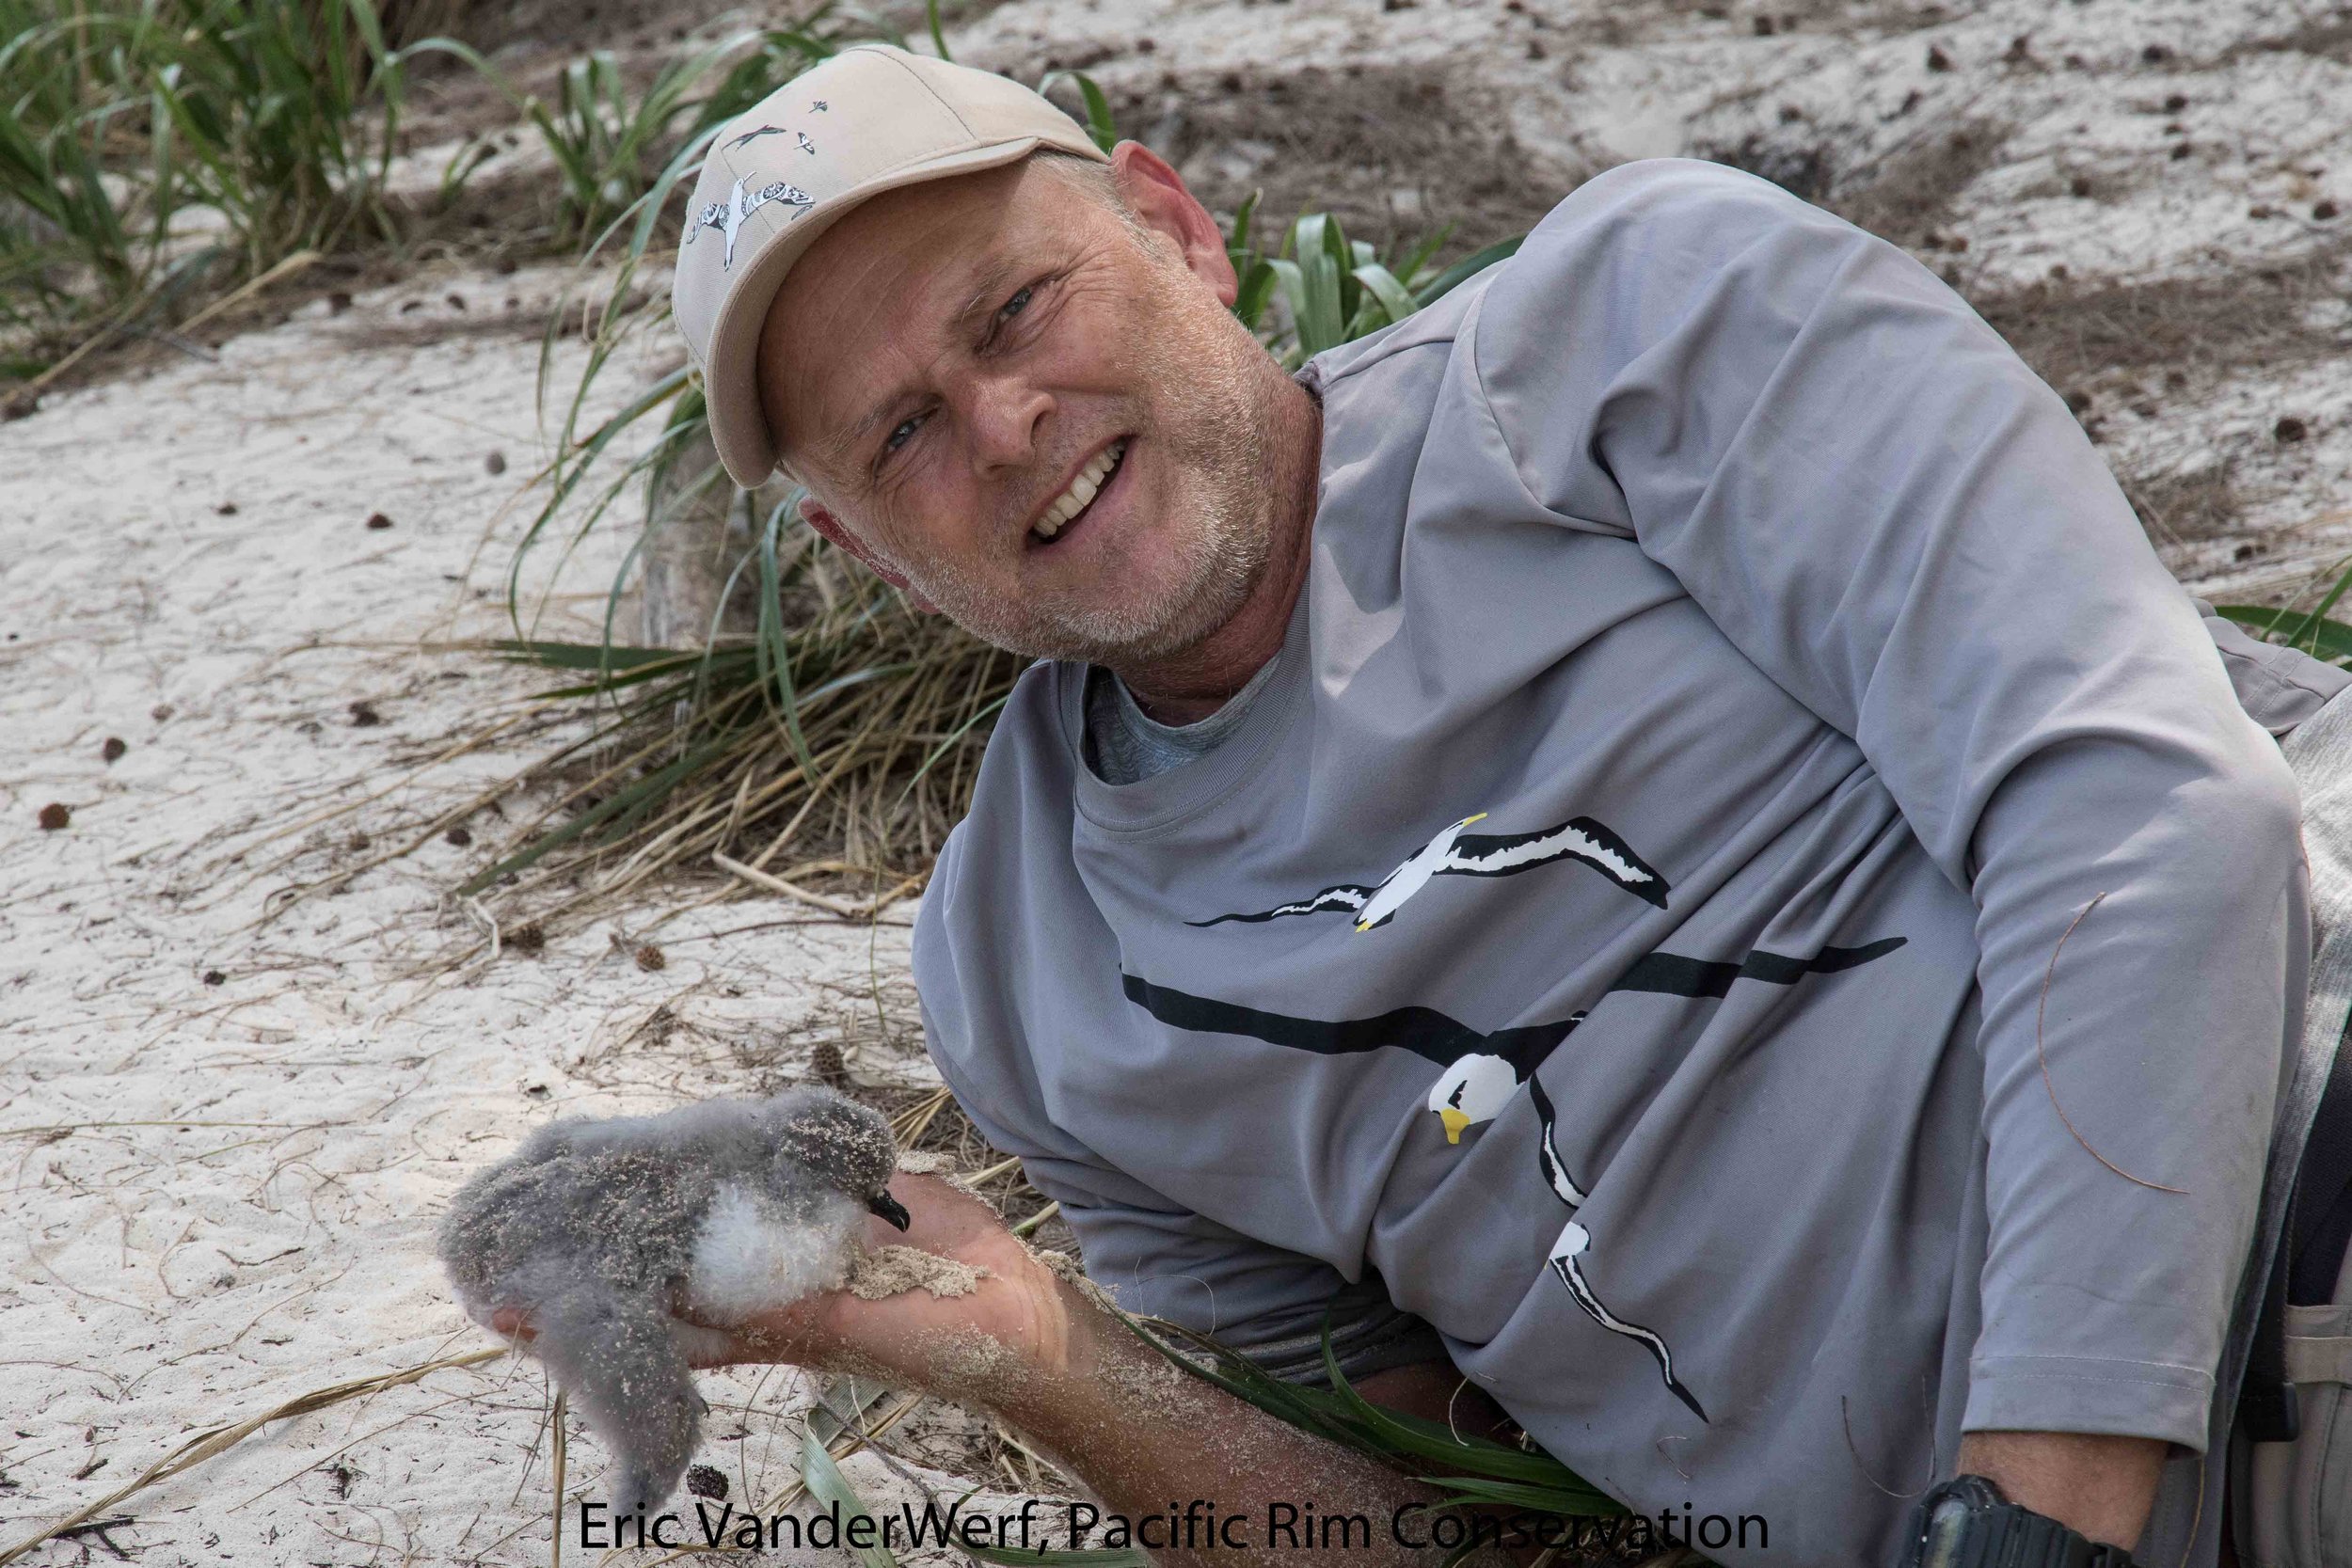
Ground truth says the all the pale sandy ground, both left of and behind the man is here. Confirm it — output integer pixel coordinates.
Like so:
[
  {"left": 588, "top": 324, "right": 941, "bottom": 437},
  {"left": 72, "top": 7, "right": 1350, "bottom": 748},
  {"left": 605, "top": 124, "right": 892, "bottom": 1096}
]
[{"left": 0, "top": 0, "right": 2352, "bottom": 1568}]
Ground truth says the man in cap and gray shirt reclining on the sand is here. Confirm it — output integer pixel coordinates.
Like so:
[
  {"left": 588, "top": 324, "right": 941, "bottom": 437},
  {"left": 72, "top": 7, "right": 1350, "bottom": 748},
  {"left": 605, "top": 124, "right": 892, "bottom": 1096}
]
[{"left": 644, "top": 49, "right": 2345, "bottom": 1563}]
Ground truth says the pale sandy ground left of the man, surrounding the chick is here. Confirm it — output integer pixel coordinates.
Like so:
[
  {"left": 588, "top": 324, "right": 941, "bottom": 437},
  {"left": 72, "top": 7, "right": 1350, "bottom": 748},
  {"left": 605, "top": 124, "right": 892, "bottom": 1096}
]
[{"left": 0, "top": 262, "right": 993, "bottom": 1563}]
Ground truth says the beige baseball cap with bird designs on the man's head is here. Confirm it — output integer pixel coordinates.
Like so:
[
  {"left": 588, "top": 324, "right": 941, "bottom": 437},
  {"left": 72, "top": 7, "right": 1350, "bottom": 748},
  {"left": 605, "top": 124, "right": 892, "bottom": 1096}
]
[{"left": 671, "top": 44, "right": 1104, "bottom": 489}]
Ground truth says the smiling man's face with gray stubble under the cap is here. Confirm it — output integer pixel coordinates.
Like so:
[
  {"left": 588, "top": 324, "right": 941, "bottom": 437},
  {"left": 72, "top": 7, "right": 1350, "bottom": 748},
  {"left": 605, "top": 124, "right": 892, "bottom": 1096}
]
[{"left": 760, "top": 147, "right": 1282, "bottom": 668}]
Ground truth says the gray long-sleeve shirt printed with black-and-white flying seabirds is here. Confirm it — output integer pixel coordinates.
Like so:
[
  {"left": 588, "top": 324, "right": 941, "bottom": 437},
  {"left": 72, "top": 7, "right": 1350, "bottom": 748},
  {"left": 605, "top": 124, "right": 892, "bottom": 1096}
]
[{"left": 915, "top": 162, "right": 2343, "bottom": 1563}]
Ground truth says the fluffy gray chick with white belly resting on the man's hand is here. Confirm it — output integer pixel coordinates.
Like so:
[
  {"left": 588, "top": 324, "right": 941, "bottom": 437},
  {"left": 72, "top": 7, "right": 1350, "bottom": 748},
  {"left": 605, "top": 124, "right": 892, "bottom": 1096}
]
[{"left": 440, "top": 1088, "right": 908, "bottom": 1514}]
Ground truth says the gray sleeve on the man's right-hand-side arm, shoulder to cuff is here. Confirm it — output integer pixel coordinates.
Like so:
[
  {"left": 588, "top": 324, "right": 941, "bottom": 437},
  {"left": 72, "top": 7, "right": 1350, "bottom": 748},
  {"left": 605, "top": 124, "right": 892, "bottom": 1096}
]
[{"left": 1470, "top": 160, "right": 2308, "bottom": 1449}]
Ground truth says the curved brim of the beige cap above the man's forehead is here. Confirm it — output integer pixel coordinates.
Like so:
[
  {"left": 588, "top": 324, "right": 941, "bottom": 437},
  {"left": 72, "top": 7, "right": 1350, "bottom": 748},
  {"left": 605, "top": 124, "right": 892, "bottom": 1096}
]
[{"left": 704, "top": 136, "right": 1068, "bottom": 489}]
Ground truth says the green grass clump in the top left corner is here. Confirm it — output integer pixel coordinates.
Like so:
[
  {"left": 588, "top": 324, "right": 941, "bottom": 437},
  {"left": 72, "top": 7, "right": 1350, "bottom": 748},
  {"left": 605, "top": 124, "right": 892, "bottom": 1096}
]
[{"left": 0, "top": 0, "right": 428, "bottom": 373}]
